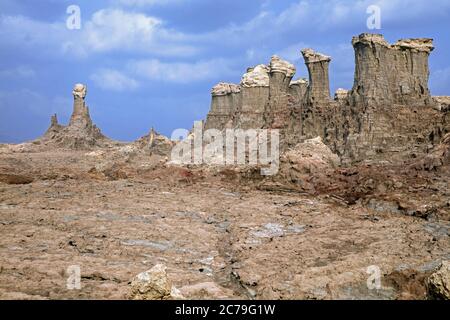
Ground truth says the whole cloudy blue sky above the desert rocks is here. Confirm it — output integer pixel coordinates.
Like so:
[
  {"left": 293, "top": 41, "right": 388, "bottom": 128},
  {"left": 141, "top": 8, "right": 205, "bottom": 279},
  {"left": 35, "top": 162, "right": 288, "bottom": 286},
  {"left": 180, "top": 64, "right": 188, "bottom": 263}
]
[{"left": 0, "top": 0, "right": 450, "bottom": 143}]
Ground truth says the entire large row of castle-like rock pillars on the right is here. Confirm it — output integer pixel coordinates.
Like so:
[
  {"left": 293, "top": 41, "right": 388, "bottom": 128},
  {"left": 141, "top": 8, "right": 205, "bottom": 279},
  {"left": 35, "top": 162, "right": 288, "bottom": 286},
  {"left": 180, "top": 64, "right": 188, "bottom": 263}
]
[{"left": 206, "top": 34, "right": 450, "bottom": 164}]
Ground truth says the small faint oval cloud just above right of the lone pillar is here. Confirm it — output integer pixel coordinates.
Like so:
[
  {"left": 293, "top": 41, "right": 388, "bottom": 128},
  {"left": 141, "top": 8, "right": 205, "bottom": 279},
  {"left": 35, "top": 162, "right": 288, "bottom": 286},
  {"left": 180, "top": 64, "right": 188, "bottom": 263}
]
[{"left": 91, "top": 69, "right": 140, "bottom": 91}]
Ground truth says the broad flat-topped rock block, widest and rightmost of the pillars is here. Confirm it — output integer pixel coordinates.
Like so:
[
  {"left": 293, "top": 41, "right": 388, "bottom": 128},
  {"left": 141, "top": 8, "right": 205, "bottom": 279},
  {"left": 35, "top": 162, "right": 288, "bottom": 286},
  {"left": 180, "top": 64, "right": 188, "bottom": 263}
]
[{"left": 351, "top": 33, "right": 434, "bottom": 106}]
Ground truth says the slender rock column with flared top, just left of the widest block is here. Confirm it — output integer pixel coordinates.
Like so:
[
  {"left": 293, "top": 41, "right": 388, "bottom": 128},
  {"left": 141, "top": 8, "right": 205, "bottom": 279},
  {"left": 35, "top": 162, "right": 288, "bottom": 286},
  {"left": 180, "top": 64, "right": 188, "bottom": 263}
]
[{"left": 302, "top": 49, "right": 331, "bottom": 105}]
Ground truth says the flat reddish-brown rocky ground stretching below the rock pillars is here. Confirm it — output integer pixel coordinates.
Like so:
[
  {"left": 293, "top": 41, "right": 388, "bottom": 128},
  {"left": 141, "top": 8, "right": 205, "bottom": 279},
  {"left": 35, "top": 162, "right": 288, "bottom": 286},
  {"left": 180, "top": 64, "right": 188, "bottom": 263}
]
[{"left": 0, "top": 140, "right": 450, "bottom": 299}]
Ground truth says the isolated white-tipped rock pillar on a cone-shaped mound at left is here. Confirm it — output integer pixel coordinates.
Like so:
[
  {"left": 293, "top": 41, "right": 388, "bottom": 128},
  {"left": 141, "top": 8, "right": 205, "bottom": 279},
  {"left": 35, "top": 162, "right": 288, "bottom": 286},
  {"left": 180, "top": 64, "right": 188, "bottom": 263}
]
[{"left": 41, "top": 84, "right": 110, "bottom": 149}]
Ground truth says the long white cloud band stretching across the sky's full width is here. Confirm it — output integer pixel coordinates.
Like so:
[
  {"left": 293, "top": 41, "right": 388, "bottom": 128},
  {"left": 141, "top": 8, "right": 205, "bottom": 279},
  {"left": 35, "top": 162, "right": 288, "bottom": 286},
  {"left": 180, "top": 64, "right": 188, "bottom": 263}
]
[{"left": 0, "top": 0, "right": 450, "bottom": 61}]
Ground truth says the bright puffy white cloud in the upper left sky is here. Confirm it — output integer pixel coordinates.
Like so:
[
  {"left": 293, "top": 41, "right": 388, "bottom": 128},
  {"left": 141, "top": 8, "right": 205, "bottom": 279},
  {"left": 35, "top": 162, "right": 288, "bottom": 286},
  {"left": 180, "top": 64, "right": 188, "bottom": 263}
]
[{"left": 0, "top": 9, "right": 200, "bottom": 58}]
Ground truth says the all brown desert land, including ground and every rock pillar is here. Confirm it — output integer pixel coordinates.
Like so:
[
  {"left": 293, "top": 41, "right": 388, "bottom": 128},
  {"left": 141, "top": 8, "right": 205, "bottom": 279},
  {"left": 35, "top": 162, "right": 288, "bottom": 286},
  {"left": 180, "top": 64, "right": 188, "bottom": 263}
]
[{"left": 0, "top": 34, "right": 450, "bottom": 299}]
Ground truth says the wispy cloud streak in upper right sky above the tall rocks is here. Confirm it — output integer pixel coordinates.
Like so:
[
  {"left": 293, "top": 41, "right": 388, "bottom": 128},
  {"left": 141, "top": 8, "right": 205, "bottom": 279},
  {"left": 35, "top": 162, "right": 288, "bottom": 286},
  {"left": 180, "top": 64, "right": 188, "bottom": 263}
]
[{"left": 197, "top": 0, "right": 450, "bottom": 45}]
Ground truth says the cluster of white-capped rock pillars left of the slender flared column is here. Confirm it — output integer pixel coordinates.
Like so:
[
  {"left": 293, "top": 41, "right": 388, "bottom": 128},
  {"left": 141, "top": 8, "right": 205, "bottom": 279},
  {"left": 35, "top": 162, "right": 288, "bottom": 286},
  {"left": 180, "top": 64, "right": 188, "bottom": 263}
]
[{"left": 205, "top": 56, "right": 308, "bottom": 136}]
